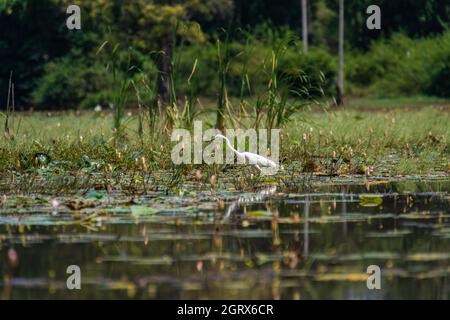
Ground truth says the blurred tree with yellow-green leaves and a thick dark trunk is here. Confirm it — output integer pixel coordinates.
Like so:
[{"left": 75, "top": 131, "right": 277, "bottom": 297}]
[{"left": 57, "top": 0, "right": 232, "bottom": 103}]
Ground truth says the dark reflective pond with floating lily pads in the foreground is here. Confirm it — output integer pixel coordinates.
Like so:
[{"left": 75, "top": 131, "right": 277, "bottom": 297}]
[{"left": 0, "top": 179, "right": 450, "bottom": 299}]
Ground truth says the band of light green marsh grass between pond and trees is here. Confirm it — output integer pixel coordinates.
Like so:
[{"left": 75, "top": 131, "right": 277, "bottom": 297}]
[{"left": 0, "top": 99, "right": 450, "bottom": 192}]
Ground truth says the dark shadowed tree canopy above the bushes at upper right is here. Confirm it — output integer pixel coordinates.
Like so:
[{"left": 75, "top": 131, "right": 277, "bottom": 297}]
[{"left": 234, "top": 0, "right": 450, "bottom": 50}]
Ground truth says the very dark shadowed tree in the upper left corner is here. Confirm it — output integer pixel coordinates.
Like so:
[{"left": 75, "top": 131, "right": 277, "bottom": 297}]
[{"left": 0, "top": 0, "right": 69, "bottom": 108}]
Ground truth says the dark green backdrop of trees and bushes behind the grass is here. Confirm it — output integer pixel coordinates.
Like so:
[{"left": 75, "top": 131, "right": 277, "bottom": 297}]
[{"left": 0, "top": 0, "right": 450, "bottom": 108}]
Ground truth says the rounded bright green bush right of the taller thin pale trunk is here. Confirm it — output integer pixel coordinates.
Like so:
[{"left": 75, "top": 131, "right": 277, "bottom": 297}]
[{"left": 347, "top": 31, "right": 450, "bottom": 97}]
